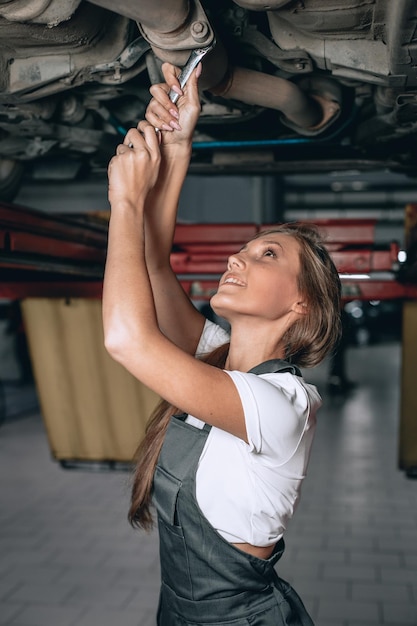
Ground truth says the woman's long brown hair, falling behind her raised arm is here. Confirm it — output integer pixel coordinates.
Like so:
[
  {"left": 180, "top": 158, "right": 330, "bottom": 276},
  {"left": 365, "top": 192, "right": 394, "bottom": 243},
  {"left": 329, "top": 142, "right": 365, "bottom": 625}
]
[{"left": 128, "top": 222, "right": 341, "bottom": 530}]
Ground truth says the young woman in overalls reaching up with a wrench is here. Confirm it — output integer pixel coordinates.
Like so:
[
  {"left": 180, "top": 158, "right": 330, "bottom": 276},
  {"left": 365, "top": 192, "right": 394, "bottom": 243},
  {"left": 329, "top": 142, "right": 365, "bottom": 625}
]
[{"left": 103, "top": 64, "right": 340, "bottom": 626}]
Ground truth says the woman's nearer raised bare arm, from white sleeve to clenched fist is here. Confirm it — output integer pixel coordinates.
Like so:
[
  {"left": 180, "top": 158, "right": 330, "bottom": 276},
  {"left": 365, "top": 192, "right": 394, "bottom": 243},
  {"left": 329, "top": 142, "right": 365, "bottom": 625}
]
[{"left": 103, "top": 114, "right": 246, "bottom": 439}]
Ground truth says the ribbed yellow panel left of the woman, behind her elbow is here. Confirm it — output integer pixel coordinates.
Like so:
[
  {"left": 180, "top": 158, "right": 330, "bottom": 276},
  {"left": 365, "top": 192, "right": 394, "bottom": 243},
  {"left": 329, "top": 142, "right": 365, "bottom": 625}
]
[{"left": 22, "top": 298, "right": 159, "bottom": 462}]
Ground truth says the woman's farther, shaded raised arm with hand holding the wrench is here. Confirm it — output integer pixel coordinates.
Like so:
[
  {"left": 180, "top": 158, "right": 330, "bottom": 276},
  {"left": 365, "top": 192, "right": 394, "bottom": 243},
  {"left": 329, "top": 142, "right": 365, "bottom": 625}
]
[{"left": 139, "top": 63, "right": 204, "bottom": 354}]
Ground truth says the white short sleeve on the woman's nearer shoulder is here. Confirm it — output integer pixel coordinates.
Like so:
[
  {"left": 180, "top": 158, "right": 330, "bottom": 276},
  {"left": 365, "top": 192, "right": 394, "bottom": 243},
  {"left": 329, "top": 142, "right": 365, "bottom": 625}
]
[{"left": 225, "top": 370, "right": 318, "bottom": 466}]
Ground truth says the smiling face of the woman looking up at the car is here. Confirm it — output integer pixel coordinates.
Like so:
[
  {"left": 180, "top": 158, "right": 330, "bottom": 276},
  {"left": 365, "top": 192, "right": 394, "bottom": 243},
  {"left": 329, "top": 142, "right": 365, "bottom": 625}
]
[{"left": 211, "top": 232, "right": 302, "bottom": 321}]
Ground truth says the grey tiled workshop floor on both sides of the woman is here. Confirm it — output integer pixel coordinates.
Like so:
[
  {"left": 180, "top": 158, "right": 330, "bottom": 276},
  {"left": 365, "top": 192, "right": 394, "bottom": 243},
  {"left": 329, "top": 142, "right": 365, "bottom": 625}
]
[{"left": 0, "top": 343, "right": 417, "bottom": 626}]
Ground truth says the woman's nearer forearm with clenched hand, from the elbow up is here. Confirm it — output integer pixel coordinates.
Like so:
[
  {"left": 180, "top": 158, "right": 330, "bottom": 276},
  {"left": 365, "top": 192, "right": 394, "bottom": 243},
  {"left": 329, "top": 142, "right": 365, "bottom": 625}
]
[{"left": 103, "top": 123, "right": 161, "bottom": 358}]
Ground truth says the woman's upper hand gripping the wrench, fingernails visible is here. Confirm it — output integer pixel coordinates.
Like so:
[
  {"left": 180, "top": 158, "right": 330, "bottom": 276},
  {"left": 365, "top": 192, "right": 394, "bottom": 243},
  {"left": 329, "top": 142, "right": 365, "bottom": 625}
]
[{"left": 145, "top": 63, "right": 201, "bottom": 146}]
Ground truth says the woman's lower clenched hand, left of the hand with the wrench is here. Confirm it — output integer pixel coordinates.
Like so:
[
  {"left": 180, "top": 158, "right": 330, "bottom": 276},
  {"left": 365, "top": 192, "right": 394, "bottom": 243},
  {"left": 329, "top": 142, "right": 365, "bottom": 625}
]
[{"left": 108, "top": 121, "right": 161, "bottom": 207}]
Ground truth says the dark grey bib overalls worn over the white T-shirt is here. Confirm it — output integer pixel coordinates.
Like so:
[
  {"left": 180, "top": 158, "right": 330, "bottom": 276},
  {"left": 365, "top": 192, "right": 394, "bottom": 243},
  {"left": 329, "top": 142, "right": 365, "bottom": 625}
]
[{"left": 153, "top": 361, "right": 314, "bottom": 626}]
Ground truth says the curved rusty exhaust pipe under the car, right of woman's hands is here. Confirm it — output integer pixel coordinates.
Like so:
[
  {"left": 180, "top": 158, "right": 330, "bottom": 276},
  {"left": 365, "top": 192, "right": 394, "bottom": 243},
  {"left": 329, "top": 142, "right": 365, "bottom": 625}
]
[{"left": 210, "top": 67, "right": 323, "bottom": 128}]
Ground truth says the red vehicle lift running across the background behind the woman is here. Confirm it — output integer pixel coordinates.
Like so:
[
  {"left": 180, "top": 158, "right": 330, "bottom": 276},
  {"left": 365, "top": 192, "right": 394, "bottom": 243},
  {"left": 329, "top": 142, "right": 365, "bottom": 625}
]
[{"left": 0, "top": 204, "right": 417, "bottom": 301}]
